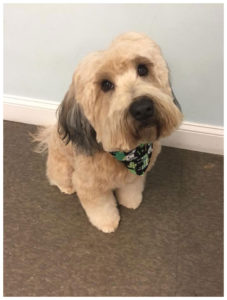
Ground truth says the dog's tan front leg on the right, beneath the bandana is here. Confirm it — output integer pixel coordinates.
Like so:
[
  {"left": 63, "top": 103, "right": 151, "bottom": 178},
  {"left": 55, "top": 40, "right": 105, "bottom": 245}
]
[{"left": 116, "top": 175, "right": 146, "bottom": 209}]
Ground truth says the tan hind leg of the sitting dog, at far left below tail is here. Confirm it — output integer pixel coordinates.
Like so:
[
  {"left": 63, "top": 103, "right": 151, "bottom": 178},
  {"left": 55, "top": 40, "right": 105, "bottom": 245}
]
[{"left": 47, "top": 149, "right": 75, "bottom": 194}]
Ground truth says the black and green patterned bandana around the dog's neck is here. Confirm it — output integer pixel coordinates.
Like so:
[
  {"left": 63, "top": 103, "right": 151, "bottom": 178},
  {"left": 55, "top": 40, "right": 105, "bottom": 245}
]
[{"left": 110, "top": 143, "right": 153, "bottom": 175}]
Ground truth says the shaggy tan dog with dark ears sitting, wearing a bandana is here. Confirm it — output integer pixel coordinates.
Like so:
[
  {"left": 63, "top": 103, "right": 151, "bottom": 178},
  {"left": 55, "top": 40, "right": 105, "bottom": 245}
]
[{"left": 34, "top": 32, "right": 183, "bottom": 233}]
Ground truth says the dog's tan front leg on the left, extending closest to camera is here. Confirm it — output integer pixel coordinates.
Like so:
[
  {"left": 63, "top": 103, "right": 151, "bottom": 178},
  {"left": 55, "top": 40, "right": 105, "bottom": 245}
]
[{"left": 77, "top": 190, "right": 120, "bottom": 233}]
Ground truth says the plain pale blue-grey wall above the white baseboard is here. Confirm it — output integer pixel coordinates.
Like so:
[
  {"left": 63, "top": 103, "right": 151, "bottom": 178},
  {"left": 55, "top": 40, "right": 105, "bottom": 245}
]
[{"left": 4, "top": 4, "right": 223, "bottom": 126}]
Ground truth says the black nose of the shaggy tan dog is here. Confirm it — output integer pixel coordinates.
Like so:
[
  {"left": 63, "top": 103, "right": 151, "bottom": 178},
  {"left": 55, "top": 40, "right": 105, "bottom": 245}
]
[{"left": 129, "top": 96, "right": 154, "bottom": 121}]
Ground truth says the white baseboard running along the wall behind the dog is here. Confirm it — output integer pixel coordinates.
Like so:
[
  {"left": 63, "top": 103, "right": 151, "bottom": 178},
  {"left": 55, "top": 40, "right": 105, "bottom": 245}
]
[{"left": 3, "top": 95, "right": 224, "bottom": 155}]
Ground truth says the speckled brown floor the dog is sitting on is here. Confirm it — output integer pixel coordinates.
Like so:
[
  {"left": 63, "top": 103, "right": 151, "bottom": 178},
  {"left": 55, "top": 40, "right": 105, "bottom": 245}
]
[{"left": 4, "top": 122, "right": 223, "bottom": 296}]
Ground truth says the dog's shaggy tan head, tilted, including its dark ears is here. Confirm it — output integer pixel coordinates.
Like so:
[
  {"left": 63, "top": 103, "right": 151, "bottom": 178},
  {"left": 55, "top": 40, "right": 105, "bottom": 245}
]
[{"left": 59, "top": 33, "right": 182, "bottom": 154}]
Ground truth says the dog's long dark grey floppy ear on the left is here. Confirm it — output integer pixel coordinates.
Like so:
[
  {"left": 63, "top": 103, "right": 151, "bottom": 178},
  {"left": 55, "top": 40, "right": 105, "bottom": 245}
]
[{"left": 57, "top": 84, "right": 101, "bottom": 155}]
